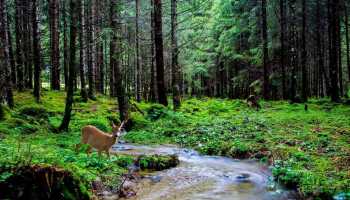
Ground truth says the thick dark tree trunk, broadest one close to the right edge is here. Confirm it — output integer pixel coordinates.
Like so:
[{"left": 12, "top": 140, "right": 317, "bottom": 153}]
[{"left": 328, "top": 0, "right": 340, "bottom": 102}]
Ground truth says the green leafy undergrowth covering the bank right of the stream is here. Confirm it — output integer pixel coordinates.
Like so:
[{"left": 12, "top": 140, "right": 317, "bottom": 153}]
[{"left": 125, "top": 98, "right": 350, "bottom": 199}]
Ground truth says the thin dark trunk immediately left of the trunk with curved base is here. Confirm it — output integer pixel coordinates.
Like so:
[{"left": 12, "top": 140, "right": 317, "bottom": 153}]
[{"left": 63, "top": 0, "right": 69, "bottom": 90}]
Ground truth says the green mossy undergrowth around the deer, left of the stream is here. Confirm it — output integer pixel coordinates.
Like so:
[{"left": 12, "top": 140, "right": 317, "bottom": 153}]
[{"left": 0, "top": 92, "right": 178, "bottom": 199}]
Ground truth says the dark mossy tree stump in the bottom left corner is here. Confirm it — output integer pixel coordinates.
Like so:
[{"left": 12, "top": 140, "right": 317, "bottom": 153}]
[{"left": 0, "top": 165, "right": 90, "bottom": 200}]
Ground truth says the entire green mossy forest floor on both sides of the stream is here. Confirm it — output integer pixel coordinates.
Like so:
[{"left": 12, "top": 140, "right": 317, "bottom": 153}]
[{"left": 0, "top": 91, "right": 350, "bottom": 199}]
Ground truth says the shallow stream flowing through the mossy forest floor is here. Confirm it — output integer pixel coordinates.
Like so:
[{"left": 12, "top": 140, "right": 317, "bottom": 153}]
[{"left": 113, "top": 144, "right": 297, "bottom": 200}]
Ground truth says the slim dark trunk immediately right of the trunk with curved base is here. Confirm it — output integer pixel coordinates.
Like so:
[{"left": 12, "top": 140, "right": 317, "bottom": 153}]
[{"left": 78, "top": 0, "right": 88, "bottom": 102}]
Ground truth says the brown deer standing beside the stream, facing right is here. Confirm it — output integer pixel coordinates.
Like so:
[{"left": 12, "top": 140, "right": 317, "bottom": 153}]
[{"left": 76, "top": 120, "right": 127, "bottom": 158}]
